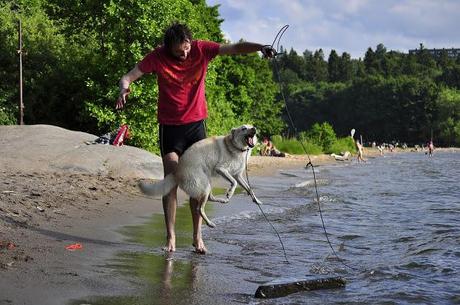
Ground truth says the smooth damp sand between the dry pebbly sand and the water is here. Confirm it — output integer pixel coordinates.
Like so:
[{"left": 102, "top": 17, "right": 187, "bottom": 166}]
[{"left": 0, "top": 173, "right": 161, "bottom": 304}]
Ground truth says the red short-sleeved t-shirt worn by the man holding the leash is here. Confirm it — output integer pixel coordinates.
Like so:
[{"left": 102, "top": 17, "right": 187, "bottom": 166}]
[{"left": 138, "top": 40, "right": 219, "bottom": 125}]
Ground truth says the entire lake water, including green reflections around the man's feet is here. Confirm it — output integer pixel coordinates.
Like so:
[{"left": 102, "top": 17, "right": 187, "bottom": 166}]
[{"left": 72, "top": 152, "right": 460, "bottom": 304}]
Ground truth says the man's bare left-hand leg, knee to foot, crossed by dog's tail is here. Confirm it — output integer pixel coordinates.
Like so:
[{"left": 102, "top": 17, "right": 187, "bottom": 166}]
[{"left": 163, "top": 152, "right": 179, "bottom": 252}]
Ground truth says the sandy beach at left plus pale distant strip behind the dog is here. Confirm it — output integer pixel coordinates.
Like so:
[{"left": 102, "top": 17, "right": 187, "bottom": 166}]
[{"left": 0, "top": 124, "right": 396, "bottom": 304}]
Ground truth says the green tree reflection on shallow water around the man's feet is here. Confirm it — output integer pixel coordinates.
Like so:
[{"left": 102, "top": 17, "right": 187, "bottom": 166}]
[{"left": 71, "top": 204, "right": 212, "bottom": 305}]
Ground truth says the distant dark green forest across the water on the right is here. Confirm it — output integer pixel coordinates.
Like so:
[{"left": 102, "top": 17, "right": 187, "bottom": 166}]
[{"left": 272, "top": 44, "right": 460, "bottom": 146}]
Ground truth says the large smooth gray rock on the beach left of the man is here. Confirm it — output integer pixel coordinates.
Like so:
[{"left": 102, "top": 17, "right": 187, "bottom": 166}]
[{"left": 0, "top": 125, "right": 163, "bottom": 179}]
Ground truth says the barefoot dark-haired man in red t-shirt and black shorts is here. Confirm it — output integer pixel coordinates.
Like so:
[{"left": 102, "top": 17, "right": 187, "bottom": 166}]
[{"left": 116, "top": 23, "right": 276, "bottom": 254}]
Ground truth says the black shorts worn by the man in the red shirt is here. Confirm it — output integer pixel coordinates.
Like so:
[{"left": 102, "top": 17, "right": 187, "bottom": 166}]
[{"left": 159, "top": 120, "right": 206, "bottom": 157}]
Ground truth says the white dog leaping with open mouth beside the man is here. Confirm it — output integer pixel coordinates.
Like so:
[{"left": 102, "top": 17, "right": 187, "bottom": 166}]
[{"left": 139, "top": 125, "right": 262, "bottom": 227}]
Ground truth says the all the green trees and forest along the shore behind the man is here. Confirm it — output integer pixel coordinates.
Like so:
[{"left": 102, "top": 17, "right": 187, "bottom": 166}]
[{"left": 0, "top": 0, "right": 460, "bottom": 151}]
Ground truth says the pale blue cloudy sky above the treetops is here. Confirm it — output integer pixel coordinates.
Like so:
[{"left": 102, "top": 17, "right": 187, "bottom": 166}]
[{"left": 206, "top": 0, "right": 460, "bottom": 59}]
